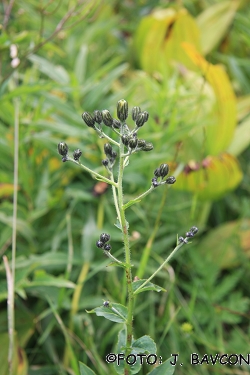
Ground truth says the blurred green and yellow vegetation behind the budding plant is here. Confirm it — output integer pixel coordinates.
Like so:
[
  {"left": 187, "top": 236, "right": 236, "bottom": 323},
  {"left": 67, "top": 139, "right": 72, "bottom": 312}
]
[{"left": 0, "top": 0, "right": 250, "bottom": 375}]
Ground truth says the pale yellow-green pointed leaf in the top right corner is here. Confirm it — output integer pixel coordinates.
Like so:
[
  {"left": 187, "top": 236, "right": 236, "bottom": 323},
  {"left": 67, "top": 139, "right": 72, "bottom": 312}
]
[{"left": 196, "top": 0, "right": 240, "bottom": 55}]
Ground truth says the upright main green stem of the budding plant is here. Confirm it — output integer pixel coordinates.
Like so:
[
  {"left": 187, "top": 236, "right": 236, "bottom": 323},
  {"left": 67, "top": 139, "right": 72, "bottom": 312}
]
[{"left": 117, "top": 125, "right": 134, "bottom": 375}]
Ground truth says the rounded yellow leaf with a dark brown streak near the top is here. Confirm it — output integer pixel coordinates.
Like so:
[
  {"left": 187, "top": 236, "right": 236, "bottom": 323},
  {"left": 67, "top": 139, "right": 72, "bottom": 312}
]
[{"left": 134, "top": 8, "right": 200, "bottom": 73}]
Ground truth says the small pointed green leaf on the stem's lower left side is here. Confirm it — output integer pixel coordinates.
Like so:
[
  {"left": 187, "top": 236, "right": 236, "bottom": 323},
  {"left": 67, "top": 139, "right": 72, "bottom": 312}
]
[{"left": 87, "top": 303, "right": 128, "bottom": 323}]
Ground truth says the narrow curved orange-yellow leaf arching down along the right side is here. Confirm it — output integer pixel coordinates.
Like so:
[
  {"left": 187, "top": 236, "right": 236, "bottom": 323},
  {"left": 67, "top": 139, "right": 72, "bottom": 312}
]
[{"left": 183, "top": 43, "right": 236, "bottom": 155}]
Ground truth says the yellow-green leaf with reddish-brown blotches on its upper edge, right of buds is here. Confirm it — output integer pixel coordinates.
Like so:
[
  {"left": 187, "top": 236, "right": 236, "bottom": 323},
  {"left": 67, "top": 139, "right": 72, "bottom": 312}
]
[{"left": 174, "top": 153, "right": 242, "bottom": 200}]
